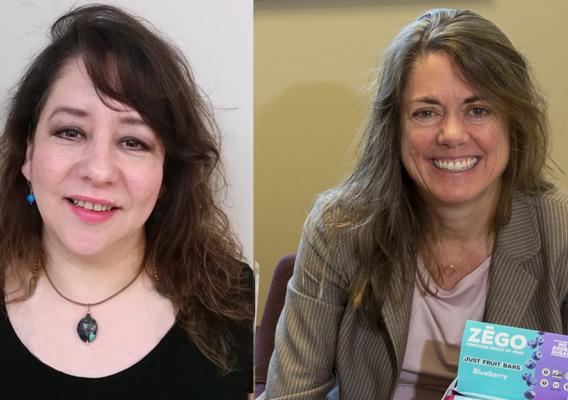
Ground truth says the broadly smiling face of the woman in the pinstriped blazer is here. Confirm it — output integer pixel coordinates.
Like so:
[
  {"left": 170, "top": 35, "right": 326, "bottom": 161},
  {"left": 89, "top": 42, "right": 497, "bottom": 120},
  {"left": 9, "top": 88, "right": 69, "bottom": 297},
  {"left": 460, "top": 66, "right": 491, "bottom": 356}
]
[{"left": 401, "top": 52, "right": 510, "bottom": 209}]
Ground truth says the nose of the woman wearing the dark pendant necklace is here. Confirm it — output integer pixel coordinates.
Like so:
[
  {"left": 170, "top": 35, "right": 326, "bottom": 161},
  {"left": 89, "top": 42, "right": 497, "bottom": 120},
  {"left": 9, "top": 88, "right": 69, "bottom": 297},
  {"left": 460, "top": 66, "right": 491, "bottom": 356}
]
[{"left": 78, "top": 136, "right": 118, "bottom": 185}]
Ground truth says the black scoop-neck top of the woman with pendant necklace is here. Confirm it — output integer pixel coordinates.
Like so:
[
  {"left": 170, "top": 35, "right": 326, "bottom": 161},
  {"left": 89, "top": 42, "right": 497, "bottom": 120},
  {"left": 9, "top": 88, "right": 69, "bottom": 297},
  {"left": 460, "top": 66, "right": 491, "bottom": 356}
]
[{"left": 0, "top": 302, "right": 253, "bottom": 400}]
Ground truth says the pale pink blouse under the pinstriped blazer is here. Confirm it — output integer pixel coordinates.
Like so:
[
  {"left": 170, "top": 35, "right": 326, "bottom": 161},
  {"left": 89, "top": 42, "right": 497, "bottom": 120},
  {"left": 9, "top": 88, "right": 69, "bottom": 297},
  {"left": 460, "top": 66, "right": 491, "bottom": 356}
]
[{"left": 393, "top": 257, "right": 491, "bottom": 400}]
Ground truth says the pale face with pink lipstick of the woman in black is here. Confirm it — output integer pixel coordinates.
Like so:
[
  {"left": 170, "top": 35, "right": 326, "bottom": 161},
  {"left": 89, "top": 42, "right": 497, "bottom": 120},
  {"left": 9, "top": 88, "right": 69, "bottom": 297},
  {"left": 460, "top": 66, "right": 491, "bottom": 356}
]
[{"left": 22, "top": 59, "right": 165, "bottom": 256}]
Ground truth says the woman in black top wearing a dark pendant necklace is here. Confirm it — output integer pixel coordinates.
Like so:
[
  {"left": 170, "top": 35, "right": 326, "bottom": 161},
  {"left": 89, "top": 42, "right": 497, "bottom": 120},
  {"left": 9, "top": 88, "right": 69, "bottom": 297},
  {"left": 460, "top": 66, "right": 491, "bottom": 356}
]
[{"left": 0, "top": 5, "right": 254, "bottom": 399}]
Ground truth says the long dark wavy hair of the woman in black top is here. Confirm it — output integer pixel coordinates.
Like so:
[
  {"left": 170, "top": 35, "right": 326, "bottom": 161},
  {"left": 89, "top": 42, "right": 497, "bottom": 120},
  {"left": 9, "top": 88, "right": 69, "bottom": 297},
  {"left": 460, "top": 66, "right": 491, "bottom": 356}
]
[{"left": 0, "top": 5, "right": 254, "bottom": 373}]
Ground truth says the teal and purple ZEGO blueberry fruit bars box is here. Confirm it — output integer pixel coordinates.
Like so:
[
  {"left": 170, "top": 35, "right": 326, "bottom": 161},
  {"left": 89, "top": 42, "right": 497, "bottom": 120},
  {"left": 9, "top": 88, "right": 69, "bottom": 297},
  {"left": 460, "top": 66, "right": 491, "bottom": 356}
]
[{"left": 456, "top": 321, "right": 568, "bottom": 400}]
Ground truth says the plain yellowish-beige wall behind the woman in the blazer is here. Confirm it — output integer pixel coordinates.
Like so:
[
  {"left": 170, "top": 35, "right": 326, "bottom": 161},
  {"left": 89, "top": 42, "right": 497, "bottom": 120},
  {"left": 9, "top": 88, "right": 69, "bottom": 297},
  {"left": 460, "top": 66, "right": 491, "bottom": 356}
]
[{"left": 254, "top": 0, "right": 568, "bottom": 316}]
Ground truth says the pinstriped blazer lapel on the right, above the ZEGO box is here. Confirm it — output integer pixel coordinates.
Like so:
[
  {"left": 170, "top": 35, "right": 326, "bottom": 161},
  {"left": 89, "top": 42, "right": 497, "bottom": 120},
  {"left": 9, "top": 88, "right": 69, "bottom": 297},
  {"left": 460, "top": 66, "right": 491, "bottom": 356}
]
[{"left": 484, "top": 196, "right": 541, "bottom": 326}]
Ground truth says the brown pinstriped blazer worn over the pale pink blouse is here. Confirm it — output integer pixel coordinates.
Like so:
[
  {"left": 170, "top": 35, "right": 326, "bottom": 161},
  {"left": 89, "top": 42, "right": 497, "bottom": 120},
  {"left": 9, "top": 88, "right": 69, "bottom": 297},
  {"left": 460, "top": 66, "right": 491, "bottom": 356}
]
[{"left": 261, "top": 191, "right": 568, "bottom": 400}]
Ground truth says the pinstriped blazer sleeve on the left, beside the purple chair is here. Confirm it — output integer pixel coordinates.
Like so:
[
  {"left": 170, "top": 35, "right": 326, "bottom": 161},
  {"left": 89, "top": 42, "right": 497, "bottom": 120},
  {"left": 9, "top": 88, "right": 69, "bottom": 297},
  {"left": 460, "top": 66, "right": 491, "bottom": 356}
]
[{"left": 261, "top": 199, "right": 352, "bottom": 400}]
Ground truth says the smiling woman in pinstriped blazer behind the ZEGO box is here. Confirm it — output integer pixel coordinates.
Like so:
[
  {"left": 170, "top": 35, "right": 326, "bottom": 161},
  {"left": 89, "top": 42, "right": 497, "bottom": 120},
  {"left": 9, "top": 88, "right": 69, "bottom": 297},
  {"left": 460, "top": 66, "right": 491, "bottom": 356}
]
[{"left": 264, "top": 9, "right": 568, "bottom": 400}]
